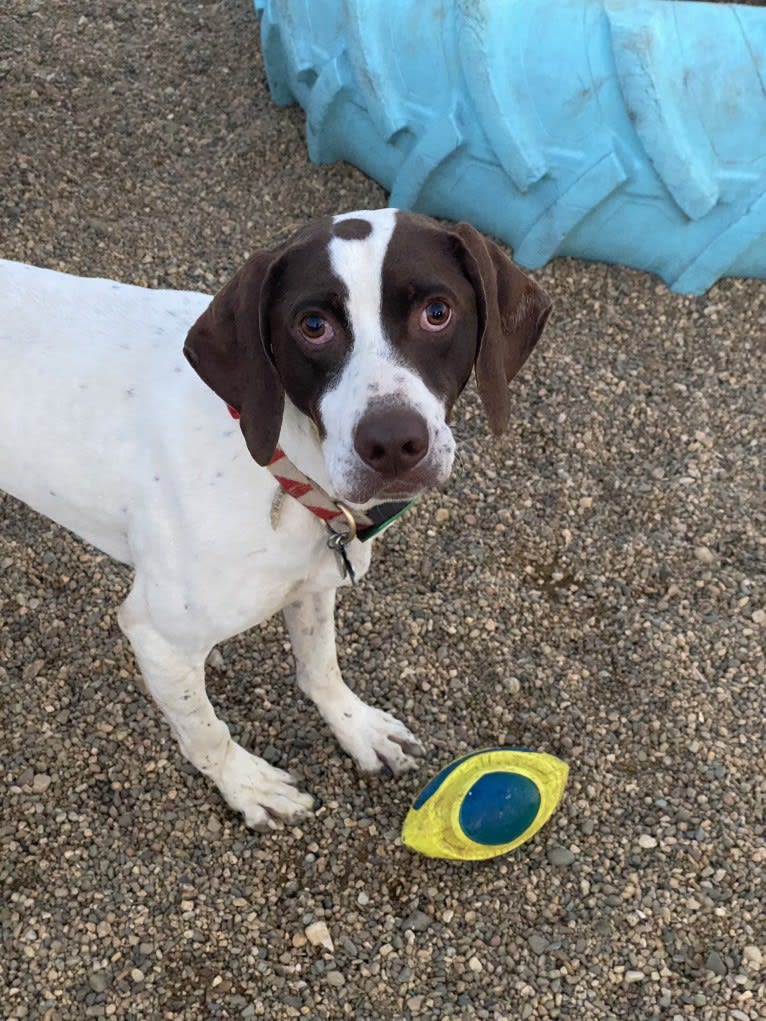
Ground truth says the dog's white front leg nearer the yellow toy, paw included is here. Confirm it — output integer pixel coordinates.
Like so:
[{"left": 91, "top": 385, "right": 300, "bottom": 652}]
[{"left": 284, "top": 589, "right": 423, "bottom": 776}]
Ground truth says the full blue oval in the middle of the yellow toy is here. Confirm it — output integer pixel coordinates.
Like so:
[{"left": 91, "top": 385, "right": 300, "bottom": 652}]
[{"left": 459, "top": 773, "right": 540, "bottom": 844}]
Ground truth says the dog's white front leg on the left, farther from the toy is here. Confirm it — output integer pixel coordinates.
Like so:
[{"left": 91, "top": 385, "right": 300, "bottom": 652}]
[{"left": 118, "top": 583, "right": 313, "bottom": 830}]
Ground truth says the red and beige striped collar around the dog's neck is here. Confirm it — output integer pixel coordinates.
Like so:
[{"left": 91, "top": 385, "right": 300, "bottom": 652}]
[{"left": 226, "top": 404, "right": 415, "bottom": 543}]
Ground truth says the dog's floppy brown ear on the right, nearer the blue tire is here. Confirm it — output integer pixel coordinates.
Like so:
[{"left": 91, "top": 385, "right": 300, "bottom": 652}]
[{"left": 454, "top": 224, "right": 550, "bottom": 435}]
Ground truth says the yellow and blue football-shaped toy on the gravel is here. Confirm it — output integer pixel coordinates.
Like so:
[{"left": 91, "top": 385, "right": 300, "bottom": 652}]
[{"left": 401, "top": 747, "right": 569, "bottom": 862}]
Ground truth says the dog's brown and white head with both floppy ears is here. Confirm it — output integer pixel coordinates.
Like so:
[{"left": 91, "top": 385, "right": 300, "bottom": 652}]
[{"left": 184, "top": 209, "right": 550, "bottom": 505}]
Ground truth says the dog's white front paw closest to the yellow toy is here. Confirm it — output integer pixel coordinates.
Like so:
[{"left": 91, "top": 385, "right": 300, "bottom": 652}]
[{"left": 329, "top": 695, "right": 424, "bottom": 776}]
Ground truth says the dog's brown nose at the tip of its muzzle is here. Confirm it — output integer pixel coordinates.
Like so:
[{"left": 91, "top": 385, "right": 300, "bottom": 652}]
[{"left": 353, "top": 407, "right": 428, "bottom": 478}]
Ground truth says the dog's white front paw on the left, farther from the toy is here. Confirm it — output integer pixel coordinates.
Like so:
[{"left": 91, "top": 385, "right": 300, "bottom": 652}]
[{"left": 218, "top": 741, "right": 314, "bottom": 830}]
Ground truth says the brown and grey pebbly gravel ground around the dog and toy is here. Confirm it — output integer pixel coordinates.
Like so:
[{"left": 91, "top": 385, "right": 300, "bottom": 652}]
[{"left": 0, "top": 0, "right": 766, "bottom": 1021}]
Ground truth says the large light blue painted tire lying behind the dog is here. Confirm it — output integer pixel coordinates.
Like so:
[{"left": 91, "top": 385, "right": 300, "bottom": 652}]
[{"left": 255, "top": 0, "right": 766, "bottom": 294}]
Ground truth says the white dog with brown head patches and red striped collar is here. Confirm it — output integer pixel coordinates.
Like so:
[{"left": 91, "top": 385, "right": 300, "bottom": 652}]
[{"left": 0, "top": 208, "right": 550, "bottom": 829}]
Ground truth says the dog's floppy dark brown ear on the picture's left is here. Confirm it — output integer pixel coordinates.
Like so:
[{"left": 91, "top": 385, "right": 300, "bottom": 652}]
[{"left": 184, "top": 252, "right": 285, "bottom": 465}]
